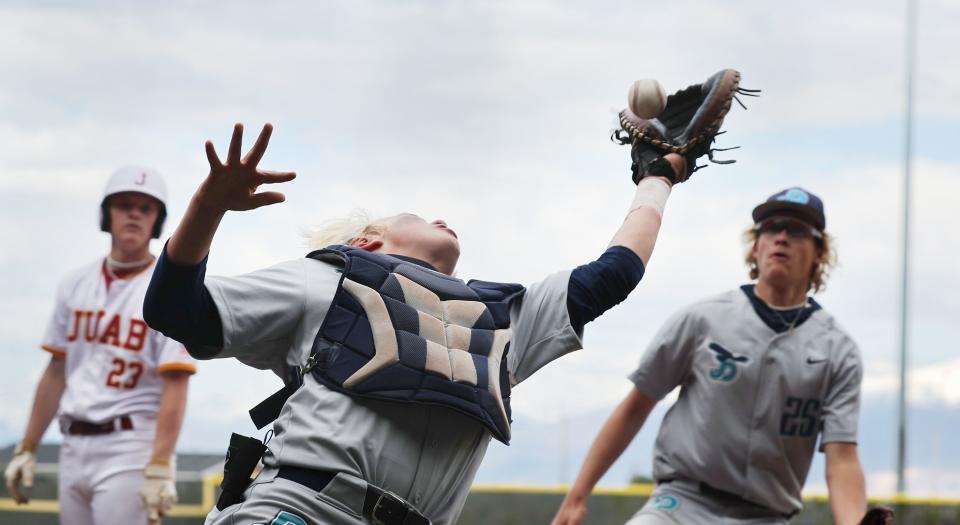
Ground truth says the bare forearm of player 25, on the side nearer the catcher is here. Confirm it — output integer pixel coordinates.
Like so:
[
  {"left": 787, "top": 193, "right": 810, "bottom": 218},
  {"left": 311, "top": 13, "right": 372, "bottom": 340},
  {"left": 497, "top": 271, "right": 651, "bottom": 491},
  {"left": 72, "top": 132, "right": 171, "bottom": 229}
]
[{"left": 565, "top": 388, "right": 656, "bottom": 502}]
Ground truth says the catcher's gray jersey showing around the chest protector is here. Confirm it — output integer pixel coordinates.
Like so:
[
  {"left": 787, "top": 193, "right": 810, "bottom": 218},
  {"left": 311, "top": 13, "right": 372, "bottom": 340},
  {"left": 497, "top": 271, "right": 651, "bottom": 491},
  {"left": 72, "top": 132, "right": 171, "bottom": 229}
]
[{"left": 205, "top": 258, "right": 581, "bottom": 525}]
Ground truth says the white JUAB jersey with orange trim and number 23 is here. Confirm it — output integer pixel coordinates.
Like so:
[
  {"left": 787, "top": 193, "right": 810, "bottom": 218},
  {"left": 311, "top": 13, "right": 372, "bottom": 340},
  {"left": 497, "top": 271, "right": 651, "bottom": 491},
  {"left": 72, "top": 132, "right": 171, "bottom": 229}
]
[{"left": 42, "top": 259, "right": 196, "bottom": 422}]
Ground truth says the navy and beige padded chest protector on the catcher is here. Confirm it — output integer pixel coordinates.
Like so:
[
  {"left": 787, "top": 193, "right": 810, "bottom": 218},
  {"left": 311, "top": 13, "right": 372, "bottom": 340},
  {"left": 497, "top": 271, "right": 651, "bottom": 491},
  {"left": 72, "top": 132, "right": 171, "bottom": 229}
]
[{"left": 307, "top": 245, "right": 524, "bottom": 443}]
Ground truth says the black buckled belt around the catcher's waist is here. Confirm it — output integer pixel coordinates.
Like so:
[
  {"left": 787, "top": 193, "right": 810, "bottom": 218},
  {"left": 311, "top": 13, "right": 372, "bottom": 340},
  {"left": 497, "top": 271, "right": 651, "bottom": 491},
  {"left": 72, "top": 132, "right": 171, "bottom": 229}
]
[{"left": 277, "top": 465, "right": 430, "bottom": 525}]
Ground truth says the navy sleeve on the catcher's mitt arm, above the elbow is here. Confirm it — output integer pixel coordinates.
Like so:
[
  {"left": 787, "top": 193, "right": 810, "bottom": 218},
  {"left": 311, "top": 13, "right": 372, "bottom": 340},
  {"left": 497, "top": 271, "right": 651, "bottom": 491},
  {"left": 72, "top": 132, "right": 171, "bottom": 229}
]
[{"left": 567, "top": 246, "right": 643, "bottom": 333}]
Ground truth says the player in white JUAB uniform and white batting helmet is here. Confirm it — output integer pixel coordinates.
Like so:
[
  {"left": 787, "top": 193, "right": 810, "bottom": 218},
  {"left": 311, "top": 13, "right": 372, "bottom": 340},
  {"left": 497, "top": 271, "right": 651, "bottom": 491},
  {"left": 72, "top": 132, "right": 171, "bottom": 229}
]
[{"left": 6, "top": 167, "right": 196, "bottom": 525}]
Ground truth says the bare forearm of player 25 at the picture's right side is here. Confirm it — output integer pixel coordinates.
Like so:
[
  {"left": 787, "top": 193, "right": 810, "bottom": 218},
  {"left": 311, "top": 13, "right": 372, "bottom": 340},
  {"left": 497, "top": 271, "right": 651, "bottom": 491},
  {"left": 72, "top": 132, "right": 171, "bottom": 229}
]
[{"left": 826, "top": 445, "right": 867, "bottom": 525}]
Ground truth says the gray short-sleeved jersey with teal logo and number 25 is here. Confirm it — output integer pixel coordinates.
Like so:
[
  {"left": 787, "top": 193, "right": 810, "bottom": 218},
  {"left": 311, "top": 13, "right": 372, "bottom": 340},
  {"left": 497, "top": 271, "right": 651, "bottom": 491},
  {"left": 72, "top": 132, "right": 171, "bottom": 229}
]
[{"left": 630, "top": 290, "right": 862, "bottom": 513}]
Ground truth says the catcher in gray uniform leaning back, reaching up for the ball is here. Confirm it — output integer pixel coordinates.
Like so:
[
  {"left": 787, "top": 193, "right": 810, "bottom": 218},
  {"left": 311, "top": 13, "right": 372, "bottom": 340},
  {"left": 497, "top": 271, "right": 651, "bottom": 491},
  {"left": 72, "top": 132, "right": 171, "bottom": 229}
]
[{"left": 144, "top": 124, "right": 687, "bottom": 525}]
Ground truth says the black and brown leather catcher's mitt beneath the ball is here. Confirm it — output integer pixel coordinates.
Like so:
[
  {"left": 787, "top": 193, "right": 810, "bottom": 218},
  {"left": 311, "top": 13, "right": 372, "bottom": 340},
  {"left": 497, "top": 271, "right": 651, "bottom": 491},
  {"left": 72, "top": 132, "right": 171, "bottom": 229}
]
[{"left": 612, "top": 69, "right": 760, "bottom": 184}]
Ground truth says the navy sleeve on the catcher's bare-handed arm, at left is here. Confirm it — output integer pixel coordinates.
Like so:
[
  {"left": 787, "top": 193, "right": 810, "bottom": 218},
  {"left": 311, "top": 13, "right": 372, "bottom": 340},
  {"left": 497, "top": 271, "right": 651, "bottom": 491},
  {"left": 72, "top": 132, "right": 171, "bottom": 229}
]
[{"left": 143, "top": 246, "right": 223, "bottom": 359}]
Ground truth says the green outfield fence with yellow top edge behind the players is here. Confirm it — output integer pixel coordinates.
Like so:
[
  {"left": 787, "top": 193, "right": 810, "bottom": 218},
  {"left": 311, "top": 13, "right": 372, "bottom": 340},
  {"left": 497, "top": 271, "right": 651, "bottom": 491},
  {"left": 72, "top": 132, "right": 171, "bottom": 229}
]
[{"left": 0, "top": 472, "right": 960, "bottom": 525}]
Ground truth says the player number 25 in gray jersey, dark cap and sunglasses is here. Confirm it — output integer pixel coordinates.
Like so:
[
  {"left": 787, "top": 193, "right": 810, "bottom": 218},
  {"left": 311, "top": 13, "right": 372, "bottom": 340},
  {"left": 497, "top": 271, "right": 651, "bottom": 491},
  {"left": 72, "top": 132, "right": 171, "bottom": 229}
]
[{"left": 553, "top": 188, "right": 866, "bottom": 525}]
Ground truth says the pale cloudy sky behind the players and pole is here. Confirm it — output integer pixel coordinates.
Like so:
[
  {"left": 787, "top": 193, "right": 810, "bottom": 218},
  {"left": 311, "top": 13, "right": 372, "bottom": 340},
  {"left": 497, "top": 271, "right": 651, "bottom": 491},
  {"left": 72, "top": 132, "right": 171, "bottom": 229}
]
[{"left": 0, "top": 0, "right": 960, "bottom": 494}]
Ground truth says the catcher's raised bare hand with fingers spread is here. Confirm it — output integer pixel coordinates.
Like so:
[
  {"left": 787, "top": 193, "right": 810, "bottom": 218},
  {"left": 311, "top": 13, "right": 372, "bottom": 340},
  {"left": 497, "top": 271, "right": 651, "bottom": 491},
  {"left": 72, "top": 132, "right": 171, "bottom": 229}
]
[{"left": 196, "top": 123, "right": 297, "bottom": 212}]
